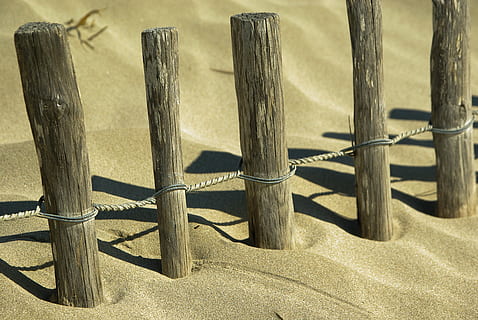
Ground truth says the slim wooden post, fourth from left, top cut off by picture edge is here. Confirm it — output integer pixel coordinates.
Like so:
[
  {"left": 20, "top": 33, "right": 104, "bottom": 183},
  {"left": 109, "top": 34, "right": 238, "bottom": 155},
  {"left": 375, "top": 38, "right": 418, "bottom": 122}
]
[{"left": 347, "top": 0, "right": 392, "bottom": 241}]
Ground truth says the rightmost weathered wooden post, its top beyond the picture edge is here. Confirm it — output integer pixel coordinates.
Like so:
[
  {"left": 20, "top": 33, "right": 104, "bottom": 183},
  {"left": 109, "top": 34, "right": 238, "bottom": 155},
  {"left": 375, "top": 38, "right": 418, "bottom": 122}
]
[{"left": 430, "top": 0, "right": 476, "bottom": 218}]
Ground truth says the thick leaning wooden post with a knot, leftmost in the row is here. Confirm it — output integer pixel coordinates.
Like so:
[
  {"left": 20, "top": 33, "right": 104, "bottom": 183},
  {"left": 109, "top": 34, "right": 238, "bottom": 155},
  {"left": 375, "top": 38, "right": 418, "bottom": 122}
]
[{"left": 15, "top": 23, "right": 103, "bottom": 307}]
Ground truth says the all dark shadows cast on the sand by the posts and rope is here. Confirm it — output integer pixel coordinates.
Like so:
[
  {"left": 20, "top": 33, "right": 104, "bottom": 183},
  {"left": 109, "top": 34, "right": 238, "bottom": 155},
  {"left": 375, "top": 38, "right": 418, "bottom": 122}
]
[{"left": 0, "top": 102, "right": 478, "bottom": 301}]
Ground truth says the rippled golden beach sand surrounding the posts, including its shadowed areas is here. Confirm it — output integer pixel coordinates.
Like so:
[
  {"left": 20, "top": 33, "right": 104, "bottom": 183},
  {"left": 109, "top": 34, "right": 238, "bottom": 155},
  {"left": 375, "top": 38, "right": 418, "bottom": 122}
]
[{"left": 0, "top": 0, "right": 478, "bottom": 319}]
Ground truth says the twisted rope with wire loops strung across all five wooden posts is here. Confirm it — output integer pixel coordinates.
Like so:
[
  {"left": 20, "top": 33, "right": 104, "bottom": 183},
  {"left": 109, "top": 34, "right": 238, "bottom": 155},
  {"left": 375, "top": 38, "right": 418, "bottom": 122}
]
[{"left": 0, "top": 111, "right": 478, "bottom": 223}]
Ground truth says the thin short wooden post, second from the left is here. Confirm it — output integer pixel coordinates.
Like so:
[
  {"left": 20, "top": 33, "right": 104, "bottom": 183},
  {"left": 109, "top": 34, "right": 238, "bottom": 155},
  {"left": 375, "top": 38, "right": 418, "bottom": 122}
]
[{"left": 141, "top": 28, "right": 192, "bottom": 278}]
